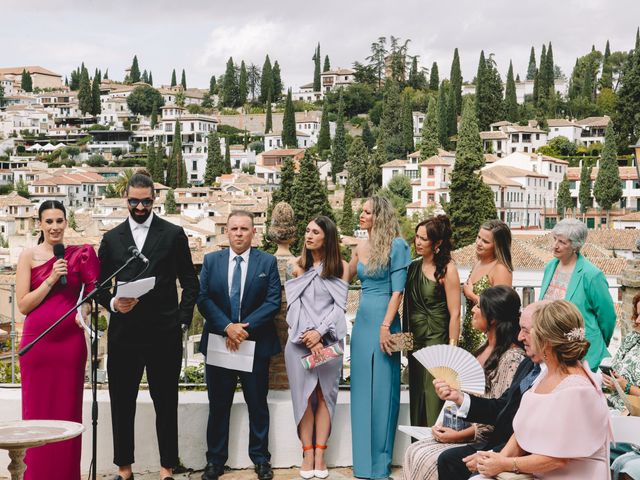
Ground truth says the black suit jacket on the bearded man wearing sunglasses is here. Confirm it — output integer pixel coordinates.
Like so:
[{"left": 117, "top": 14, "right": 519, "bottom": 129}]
[{"left": 98, "top": 215, "right": 198, "bottom": 345}]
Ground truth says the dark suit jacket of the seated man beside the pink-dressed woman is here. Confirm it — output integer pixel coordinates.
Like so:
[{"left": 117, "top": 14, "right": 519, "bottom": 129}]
[{"left": 467, "top": 357, "right": 534, "bottom": 450}]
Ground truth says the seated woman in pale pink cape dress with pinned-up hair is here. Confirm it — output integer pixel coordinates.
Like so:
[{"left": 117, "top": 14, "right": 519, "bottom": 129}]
[{"left": 474, "top": 300, "right": 611, "bottom": 480}]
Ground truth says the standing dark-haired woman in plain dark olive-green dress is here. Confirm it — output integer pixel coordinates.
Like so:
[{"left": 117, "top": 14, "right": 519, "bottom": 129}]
[{"left": 404, "top": 215, "right": 461, "bottom": 427}]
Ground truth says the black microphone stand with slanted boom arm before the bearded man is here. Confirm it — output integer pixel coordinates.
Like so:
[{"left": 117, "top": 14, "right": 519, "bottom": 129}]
[{"left": 18, "top": 255, "right": 138, "bottom": 480}]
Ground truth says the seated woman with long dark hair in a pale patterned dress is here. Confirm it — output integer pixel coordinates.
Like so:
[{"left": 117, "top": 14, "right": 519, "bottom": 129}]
[{"left": 404, "top": 285, "right": 525, "bottom": 480}]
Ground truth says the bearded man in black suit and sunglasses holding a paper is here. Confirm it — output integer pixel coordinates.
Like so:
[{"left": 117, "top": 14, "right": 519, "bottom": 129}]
[{"left": 98, "top": 173, "right": 198, "bottom": 480}]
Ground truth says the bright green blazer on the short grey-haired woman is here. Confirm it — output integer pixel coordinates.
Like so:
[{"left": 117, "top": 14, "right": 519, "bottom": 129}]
[{"left": 540, "top": 254, "right": 616, "bottom": 371}]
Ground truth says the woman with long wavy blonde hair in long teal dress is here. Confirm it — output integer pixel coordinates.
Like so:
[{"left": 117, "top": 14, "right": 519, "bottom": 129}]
[{"left": 350, "top": 196, "right": 411, "bottom": 479}]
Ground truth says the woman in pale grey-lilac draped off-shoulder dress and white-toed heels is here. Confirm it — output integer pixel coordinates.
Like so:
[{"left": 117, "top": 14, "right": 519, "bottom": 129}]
[{"left": 284, "top": 216, "right": 349, "bottom": 478}]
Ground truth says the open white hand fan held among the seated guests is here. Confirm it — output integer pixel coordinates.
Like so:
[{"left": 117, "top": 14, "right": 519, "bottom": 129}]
[{"left": 413, "top": 345, "right": 485, "bottom": 395}]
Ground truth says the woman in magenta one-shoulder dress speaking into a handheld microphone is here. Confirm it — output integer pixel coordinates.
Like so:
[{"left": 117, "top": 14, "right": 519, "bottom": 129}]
[{"left": 16, "top": 200, "right": 100, "bottom": 480}]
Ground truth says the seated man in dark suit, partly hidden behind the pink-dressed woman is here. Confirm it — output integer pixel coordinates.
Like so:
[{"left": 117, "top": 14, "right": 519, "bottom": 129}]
[{"left": 433, "top": 302, "right": 543, "bottom": 480}]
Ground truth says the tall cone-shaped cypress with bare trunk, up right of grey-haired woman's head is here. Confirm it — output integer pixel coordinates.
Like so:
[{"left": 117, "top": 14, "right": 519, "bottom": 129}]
[{"left": 593, "top": 121, "right": 622, "bottom": 223}]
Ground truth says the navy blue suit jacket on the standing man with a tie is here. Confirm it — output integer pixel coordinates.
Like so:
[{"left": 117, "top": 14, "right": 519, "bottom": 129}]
[{"left": 198, "top": 248, "right": 282, "bottom": 357}]
